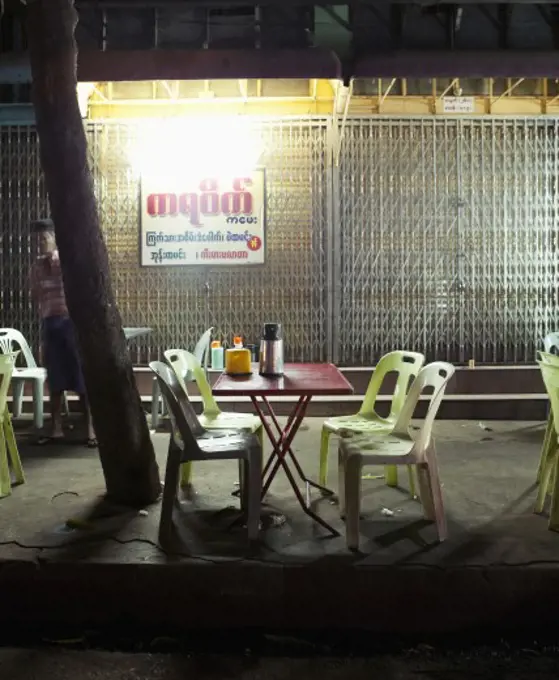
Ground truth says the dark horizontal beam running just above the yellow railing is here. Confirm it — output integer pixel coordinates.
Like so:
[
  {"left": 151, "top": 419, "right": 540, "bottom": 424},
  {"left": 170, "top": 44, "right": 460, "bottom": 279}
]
[{"left": 0, "top": 48, "right": 559, "bottom": 84}]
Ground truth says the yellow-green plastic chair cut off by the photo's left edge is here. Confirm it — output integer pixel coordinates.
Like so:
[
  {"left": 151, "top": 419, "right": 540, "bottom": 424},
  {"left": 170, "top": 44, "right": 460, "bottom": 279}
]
[{"left": 0, "top": 352, "right": 25, "bottom": 498}]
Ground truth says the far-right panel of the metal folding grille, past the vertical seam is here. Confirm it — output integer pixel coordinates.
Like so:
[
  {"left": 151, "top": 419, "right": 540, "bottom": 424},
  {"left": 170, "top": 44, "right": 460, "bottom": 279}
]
[{"left": 459, "top": 119, "right": 559, "bottom": 363}]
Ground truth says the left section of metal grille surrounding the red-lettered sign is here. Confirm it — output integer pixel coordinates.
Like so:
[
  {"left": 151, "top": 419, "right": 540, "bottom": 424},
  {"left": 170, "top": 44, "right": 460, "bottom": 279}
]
[{"left": 88, "top": 119, "right": 328, "bottom": 361}]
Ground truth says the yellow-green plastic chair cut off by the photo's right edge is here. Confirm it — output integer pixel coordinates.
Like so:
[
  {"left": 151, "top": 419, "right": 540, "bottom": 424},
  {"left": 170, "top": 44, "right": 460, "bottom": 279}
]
[{"left": 534, "top": 352, "right": 559, "bottom": 531}]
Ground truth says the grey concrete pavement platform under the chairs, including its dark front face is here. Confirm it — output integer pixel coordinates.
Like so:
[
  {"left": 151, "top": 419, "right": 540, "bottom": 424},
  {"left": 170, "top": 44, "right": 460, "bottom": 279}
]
[{"left": 0, "top": 418, "right": 559, "bottom": 633}]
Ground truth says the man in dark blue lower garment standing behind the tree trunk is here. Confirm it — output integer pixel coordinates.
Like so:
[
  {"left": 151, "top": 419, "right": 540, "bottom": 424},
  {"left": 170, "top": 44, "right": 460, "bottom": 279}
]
[{"left": 31, "top": 219, "right": 97, "bottom": 448}]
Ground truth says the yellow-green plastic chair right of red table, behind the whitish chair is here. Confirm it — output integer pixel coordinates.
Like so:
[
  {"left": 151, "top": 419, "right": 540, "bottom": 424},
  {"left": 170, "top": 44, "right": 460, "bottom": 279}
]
[{"left": 319, "top": 351, "right": 425, "bottom": 496}]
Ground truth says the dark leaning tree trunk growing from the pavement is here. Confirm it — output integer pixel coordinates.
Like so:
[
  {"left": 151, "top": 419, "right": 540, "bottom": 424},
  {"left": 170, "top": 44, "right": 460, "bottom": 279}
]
[{"left": 27, "top": 0, "right": 161, "bottom": 506}]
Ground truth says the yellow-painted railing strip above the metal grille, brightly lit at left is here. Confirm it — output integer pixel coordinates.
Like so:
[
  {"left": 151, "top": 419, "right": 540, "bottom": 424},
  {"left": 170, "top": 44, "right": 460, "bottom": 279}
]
[{"left": 88, "top": 78, "right": 559, "bottom": 119}]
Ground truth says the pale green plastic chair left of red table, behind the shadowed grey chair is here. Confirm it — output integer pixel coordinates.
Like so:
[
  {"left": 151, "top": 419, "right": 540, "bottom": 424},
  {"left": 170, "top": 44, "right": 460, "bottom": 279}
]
[{"left": 164, "top": 349, "right": 264, "bottom": 487}]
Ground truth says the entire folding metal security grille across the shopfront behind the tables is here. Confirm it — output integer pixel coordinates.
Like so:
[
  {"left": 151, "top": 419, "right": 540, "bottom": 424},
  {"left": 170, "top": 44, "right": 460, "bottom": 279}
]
[{"left": 0, "top": 118, "right": 559, "bottom": 365}]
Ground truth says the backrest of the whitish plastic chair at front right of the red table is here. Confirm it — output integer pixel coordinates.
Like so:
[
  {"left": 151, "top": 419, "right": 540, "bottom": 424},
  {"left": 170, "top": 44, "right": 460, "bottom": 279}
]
[{"left": 394, "top": 361, "right": 455, "bottom": 451}]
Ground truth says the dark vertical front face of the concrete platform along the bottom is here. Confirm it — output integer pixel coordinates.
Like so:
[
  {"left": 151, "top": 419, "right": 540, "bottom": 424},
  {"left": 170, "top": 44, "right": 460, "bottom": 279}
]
[{"left": 0, "top": 560, "right": 559, "bottom": 635}]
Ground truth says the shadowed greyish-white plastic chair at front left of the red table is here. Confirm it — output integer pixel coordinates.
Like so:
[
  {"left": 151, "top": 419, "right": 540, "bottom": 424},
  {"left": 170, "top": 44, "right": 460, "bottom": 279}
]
[{"left": 149, "top": 361, "right": 262, "bottom": 544}]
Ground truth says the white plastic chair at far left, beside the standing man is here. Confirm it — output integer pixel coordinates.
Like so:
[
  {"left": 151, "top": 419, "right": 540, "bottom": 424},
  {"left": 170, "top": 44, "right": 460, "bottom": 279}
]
[{"left": 0, "top": 328, "right": 47, "bottom": 429}]
